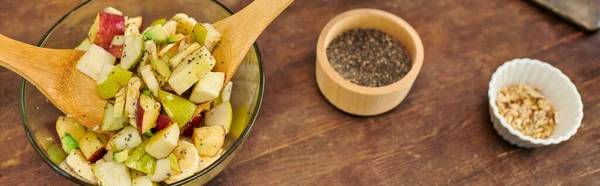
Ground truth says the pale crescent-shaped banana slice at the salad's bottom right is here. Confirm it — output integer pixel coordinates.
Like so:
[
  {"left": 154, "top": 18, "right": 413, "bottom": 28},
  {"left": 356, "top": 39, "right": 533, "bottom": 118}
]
[{"left": 165, "top": 141, "right": 200, "bottom": 184}]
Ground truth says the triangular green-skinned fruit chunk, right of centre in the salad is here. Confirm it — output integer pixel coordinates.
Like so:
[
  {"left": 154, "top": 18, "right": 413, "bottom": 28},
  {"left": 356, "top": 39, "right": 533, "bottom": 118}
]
[{"left": 158, "top": 90, "right": 198, "bottom": 128}]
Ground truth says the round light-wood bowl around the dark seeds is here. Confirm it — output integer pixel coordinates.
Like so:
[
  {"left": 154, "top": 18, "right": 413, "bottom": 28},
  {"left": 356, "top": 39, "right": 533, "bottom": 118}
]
[{"left": 316, "top": 9, "right": 424, "bottom": 116}]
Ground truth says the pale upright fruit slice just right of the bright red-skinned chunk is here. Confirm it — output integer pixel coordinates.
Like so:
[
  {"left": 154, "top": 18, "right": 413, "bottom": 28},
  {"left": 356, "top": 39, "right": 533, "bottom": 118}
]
[{"left": 120, "top": 35, "right": 144, "bottom": 70}]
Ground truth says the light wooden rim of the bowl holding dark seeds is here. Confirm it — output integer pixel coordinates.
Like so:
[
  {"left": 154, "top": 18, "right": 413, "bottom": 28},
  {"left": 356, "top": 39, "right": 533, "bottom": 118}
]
[{"left": 316, "top": 8, "right": 425, "bottom": 95}]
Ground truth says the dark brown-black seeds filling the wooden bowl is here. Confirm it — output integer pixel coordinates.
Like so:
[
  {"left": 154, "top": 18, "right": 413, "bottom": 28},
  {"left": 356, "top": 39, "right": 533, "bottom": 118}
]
[{"left": 327, "top": 29, "right": 411, "bottom": 87}]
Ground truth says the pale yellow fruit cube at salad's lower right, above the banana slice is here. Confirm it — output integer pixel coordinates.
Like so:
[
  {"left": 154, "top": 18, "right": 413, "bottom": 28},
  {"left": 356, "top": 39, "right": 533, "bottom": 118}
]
[{"left": 192, "top": 125, "right": 225, "bottom": 156}]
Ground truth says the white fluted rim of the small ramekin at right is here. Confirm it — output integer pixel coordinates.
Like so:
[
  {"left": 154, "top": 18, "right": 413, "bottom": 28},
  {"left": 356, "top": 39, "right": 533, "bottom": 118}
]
[{"left": 488, "top": 58, "right": 583, "bottom": 146}]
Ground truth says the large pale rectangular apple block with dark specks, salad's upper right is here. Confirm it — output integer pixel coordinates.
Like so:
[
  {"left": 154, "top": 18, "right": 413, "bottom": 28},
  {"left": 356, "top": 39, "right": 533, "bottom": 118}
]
[{"left": 169, "top": 43, "right": 215, "bottom": 95}]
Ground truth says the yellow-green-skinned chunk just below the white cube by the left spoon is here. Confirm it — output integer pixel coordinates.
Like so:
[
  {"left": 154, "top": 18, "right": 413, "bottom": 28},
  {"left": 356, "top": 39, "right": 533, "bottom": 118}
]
[{"left": 96, "top": 65, "right": 133, "bottom": 99}]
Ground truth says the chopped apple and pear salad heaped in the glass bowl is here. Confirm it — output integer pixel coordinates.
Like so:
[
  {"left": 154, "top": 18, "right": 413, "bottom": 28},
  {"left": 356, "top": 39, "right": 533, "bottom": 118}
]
[{"left": 56, "top": 7, "right": 232, "bottom": 186}]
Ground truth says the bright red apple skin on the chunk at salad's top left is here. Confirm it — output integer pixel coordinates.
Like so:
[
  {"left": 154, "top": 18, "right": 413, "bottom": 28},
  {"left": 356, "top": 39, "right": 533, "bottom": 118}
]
[{"left": 94, "top": 12, "right": 125, "bottom": 49}]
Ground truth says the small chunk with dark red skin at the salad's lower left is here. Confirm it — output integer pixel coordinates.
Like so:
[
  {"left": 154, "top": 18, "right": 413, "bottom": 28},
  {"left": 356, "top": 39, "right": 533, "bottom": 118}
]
[{"left": 77, "top": 131, "right": 107, "bottom": 163}]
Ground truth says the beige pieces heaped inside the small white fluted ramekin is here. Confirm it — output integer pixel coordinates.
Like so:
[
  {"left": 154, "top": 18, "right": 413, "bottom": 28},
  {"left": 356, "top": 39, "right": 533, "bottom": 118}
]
[{"left": 496, "top": 84, "right": 556, "bottom": 139}]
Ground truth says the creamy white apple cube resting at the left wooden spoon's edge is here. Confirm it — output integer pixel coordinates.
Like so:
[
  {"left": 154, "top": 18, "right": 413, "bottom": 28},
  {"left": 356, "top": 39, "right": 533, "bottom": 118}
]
[{"left": 76, "top": 44, "right": 117, "bottom": 81}]
